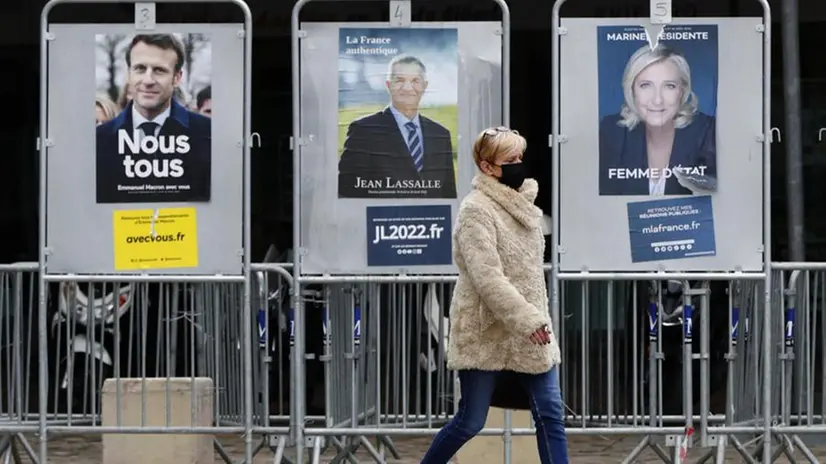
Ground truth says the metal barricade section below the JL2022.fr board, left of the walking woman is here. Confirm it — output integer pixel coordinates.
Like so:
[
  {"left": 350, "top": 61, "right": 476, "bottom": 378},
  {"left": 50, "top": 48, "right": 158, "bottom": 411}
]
[{"left": 292, "top": 277, "right": 454, "bottom": 462}]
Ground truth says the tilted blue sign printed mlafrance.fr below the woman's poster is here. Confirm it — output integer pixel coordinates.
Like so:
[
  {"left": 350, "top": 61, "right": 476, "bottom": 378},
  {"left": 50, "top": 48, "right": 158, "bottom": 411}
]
[{"left": 628, "top": 195, "right": 717, "bottom": 263}]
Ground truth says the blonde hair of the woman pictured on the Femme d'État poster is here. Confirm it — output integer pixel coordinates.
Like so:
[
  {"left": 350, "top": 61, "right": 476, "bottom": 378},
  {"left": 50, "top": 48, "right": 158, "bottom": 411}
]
[{"left": 617, "top": 45, "right": 699, "bottom": 130}]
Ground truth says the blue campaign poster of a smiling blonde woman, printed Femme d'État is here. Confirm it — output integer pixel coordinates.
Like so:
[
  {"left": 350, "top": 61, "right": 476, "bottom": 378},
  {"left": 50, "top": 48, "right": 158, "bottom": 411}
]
[{"left": 597, "top": 25, "right": 719, "bottom": 196}]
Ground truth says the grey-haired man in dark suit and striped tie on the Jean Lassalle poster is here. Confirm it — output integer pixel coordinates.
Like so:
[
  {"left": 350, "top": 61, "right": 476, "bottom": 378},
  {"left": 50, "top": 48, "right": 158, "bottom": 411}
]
[{"left": 338, "top": 55, "right": 456, "bottom": 198}]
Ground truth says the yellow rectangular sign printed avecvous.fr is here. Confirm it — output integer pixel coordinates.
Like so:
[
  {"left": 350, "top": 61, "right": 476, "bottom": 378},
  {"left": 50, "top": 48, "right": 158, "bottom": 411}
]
[{"left": 112, "top": 208, "right": 198, "bottom": 271}]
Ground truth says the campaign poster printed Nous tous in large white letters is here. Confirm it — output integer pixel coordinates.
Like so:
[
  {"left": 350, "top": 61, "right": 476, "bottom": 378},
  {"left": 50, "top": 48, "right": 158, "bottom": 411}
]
[{"left": 90, "top": 33, "right": 212, "bottom": 203}]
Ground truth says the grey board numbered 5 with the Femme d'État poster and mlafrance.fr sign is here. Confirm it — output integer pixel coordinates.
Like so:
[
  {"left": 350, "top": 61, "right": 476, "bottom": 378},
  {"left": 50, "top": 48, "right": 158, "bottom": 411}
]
[{"left": 552, "top": 17, "right": 770, "bottom": 273}]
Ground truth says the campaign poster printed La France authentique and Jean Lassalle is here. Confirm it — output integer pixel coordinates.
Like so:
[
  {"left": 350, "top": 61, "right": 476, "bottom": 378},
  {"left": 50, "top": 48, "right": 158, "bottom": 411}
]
[{"left": 338, "top": 28, "right": 459, "bottom": 198}]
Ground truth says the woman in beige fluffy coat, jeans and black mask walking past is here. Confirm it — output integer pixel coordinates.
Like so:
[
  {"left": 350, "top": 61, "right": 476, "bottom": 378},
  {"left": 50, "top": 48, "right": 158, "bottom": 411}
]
[{"left": 421, "top": 127, "right": 568, "bottom": 464}]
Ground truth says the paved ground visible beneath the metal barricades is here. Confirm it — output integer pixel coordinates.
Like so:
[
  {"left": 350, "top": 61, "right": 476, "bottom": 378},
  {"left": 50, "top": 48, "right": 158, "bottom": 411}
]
[{"left": 6, "top": 436, "right": 826, "bottom": 464}]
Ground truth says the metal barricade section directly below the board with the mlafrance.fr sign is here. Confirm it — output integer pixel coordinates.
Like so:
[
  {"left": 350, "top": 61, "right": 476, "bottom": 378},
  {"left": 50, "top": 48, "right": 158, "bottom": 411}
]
[{"left": 560, "top": 281, "right": 761, "bottom": 462}]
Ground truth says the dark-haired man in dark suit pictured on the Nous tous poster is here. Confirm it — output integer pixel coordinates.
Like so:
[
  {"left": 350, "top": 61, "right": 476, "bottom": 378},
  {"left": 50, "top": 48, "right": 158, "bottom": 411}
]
[{"left": 96, "top": 34, "right": 212, "bottom": 203}]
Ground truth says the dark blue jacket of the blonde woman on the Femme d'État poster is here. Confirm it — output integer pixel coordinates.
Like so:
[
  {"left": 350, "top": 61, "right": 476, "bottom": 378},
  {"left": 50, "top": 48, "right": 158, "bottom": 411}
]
[{"left": 599, "top": 113, "right": 717, "bottom": 196}]
